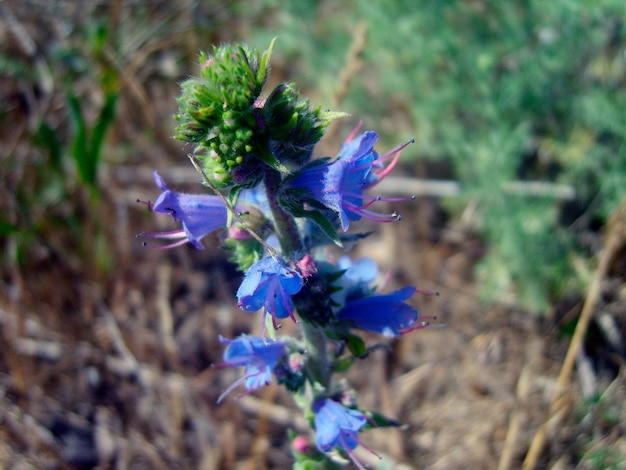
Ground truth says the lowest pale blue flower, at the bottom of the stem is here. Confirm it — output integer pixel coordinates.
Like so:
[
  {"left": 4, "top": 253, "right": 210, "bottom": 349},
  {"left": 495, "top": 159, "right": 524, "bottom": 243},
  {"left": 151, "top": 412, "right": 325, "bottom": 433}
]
[{"left": 312, "top": 398, "right": 367, "bottom": 470}]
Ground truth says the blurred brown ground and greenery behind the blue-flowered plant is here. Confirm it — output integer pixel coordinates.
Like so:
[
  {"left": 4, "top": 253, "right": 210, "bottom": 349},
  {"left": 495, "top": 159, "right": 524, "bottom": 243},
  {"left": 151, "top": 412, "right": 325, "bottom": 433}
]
[{"left": 0, "top": 0, "right": 626, "bottom": 469}]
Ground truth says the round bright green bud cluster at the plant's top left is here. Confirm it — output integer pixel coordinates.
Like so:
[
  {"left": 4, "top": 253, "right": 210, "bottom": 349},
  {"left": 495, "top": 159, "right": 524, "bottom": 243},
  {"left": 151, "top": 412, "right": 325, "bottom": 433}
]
[{"left": 175, "top": 42, "right": 274, "bottom": 187}]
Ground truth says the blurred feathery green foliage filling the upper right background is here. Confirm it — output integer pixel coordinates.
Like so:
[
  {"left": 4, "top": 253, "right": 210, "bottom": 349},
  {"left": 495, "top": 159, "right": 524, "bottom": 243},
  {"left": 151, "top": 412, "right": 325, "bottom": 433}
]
[{"left": 251, "top": 0, "right": 626, "bottom": 313}]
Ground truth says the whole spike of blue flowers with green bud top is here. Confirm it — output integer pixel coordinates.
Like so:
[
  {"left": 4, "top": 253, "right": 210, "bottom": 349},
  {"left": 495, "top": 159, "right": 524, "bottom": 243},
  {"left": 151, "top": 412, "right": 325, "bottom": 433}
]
[{"left": 140, "top": 41, "right": 426, "bottom": 468}]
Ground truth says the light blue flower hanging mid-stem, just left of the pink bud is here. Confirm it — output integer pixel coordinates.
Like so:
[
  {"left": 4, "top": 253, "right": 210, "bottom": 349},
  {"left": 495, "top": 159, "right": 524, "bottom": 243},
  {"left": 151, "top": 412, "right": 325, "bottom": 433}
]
[{"left": 237, "top": 256, "right": 303, "bottom": 329}]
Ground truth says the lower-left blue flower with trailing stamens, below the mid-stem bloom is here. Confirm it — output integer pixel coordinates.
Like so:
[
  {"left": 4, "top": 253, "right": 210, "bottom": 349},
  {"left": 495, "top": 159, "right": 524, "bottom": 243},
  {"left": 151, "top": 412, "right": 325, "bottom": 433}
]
[{"left": 216, "top": 335, "right": 287, "bottom": 403}]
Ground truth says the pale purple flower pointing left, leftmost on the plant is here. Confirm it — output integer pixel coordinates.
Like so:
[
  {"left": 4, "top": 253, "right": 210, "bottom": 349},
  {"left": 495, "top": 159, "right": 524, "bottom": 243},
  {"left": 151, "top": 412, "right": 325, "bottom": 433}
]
[{"left": 140, "top": 171, "right": 228, "bottom": 250}]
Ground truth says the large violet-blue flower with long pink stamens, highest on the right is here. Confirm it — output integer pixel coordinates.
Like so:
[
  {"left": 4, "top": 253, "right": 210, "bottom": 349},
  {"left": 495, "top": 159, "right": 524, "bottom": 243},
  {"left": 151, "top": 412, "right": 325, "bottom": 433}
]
[{"left": 289, "top": 131, "right": 413, "bottom": 231}]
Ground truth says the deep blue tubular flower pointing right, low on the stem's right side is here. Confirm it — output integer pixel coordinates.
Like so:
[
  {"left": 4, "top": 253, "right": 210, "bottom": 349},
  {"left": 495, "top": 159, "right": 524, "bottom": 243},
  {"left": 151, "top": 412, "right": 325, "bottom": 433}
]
[{"left": 335, "top": 286, "right": 416, "bottom": 336}]
